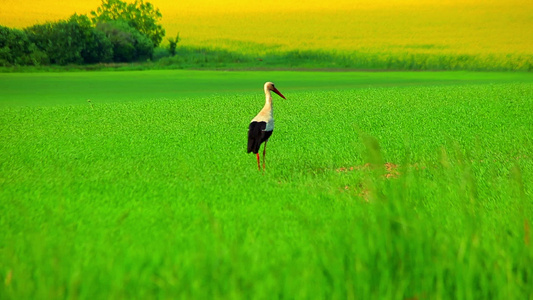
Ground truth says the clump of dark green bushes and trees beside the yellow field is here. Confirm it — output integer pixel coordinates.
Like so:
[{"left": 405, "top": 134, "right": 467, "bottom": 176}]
[{"left": 0, "top": 0, "right": 168, "bottom": 66}]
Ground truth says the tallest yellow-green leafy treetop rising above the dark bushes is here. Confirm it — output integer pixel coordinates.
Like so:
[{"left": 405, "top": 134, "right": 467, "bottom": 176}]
[{"left": 91, "top": 0, "right": 165, "bottom": 48}]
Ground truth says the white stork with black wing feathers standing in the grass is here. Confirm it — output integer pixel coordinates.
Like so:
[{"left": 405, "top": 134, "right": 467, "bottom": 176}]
[{"left": 248, "top": 82, "right": 286, "bottom": 170}]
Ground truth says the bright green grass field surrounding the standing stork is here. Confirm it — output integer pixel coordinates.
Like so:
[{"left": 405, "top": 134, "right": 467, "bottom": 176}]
[{"left": 0, "top": 71, "right": 533, "bottom": 299}]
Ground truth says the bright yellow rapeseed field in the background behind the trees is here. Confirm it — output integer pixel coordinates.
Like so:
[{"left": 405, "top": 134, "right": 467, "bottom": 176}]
[{"left": 0, "top": 0, "right": 533, "bottom": 71}]
